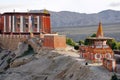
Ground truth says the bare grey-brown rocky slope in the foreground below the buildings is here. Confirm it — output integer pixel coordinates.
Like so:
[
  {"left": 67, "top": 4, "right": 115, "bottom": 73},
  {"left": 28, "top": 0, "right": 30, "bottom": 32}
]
[{"left": 0, "top": 49, "right": 111, "bottom": 80}]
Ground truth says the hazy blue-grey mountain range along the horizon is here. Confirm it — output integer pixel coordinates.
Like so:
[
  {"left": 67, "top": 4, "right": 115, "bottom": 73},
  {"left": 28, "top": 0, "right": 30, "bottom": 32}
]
[{"left": 30, "top": 10, "right": 120, "bottom": 27}]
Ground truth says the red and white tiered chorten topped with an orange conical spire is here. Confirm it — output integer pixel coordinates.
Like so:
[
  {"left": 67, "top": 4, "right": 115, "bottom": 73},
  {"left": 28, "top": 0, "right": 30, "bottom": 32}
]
[{"left": 80, "top": 23, "right": 114, "bottom": 62}]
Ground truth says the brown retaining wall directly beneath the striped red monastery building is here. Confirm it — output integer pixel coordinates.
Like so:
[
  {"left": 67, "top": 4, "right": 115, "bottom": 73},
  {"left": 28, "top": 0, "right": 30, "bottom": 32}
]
[{"left": 0, "top": 35, "right": 27, "bottom": 51}]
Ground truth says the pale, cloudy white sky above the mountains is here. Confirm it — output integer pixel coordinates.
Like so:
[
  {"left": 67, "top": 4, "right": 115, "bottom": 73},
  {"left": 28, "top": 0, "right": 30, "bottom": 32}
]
[{"left": 0, "top": 0, "right": 120, "bottom": 13}]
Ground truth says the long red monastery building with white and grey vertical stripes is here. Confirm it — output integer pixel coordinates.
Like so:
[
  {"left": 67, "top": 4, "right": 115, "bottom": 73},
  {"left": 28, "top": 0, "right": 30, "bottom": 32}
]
[{"left": 0, "top": 12, "right": 51, "bottom": 33}]
